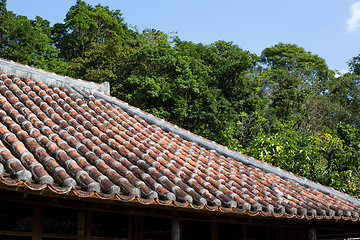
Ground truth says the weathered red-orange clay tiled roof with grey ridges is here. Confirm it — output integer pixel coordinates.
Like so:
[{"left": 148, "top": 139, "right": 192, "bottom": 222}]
[{"left": 0, "top": 60, "right": 360, "bottom": 221}]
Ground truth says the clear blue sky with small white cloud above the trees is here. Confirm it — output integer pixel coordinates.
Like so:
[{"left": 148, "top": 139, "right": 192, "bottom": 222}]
[{"left": 7, "top": 0, "right": 360, "bottom": 71}]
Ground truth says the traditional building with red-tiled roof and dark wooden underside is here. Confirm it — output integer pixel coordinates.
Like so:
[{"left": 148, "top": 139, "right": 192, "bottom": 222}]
[{"left": 0, "top": 59, "right": 360, "bottom": 240}]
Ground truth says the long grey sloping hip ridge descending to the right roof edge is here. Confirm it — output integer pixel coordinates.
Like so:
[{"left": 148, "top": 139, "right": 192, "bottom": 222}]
[{"left": 94, "top": 92, "right": 360, "bottom": 206}]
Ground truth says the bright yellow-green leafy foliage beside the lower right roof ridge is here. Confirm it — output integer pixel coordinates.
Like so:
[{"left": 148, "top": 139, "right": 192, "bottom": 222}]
[{"left": 244, "top": 123, "right": 360, "bottom": 195}]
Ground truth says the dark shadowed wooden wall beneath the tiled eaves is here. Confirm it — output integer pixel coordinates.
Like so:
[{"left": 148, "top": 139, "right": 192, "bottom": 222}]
[{"left": 0, "top": 190, "right": 360, "bottom": 240}]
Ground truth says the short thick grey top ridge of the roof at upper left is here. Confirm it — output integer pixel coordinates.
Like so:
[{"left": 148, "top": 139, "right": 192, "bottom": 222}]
[{"left": 0, "top": 58, "right": 110, "bottom": 94}]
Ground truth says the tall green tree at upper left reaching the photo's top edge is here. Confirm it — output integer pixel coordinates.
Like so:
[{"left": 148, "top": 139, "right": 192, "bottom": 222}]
[{"left": 53, "top": 0, "right": 127, "bottom": 61}]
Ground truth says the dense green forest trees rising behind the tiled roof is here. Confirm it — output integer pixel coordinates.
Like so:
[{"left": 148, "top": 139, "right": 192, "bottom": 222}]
[{"left": 0, "top": 0, "right": 360, "bottom": 195}]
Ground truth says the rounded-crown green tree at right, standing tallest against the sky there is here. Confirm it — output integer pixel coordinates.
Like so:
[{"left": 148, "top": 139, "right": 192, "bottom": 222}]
[{"left": 261, "top": 43, "right": 335, "bottom": 131}]
